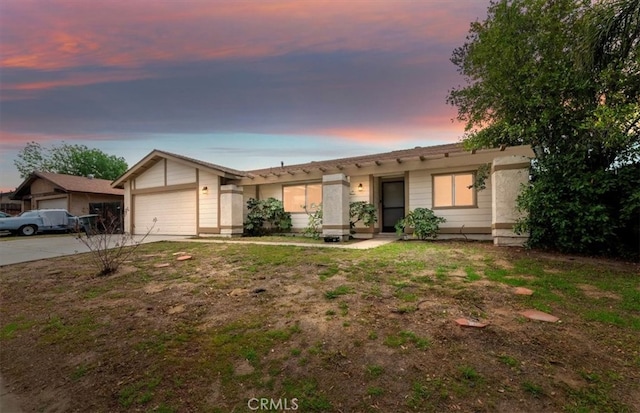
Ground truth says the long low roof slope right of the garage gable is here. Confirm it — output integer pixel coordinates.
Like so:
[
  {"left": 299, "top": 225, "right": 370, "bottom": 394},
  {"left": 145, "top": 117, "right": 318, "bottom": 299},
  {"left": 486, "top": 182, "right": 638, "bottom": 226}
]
[{"left": 246, "top": 143, "right": 465, "bottom": 175}]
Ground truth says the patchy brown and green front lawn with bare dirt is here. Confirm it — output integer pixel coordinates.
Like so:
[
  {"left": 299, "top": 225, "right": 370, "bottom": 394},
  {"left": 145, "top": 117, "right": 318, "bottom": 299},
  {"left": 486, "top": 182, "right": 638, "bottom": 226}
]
[{"left": 0, "top": 242, "right": 640, "bottom": 413}]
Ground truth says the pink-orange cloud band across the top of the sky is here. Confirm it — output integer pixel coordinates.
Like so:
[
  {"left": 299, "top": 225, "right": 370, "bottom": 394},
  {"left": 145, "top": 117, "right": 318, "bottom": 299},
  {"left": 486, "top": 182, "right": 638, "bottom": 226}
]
[{"left": 0, "top": 0, "right": 484, "bottom": 70}]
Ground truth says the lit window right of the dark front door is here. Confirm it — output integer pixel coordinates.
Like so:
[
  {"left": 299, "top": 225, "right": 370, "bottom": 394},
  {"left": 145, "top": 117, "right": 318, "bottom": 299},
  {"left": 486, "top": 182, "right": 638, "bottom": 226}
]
[{"left": 433, "top": 172, "right": 476, "bottom": 208}]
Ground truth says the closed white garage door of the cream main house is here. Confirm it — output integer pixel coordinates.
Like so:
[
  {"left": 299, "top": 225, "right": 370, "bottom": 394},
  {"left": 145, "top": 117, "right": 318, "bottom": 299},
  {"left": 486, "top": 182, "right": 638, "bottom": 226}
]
[{"left": 133, "top": 190, "right": 197, "bottom": 235}]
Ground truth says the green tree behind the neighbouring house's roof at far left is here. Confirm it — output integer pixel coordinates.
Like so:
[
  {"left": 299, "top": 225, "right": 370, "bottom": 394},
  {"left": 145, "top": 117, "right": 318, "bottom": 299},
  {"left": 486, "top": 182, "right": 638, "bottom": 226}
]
[{"left": 14, "top": 142, "right": 128, "bottom": 180}]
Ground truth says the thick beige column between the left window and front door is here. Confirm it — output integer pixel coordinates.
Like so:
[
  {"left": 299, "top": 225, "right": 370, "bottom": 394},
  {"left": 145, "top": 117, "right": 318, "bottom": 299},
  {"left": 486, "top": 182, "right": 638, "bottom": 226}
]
[{"left": 322, "top": 174, "right": 351, "bottom": 241}]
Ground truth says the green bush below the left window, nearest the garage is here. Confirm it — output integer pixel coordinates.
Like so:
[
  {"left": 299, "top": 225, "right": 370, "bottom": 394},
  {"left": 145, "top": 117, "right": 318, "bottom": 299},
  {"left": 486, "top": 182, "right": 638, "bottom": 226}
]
[{"left": 244, "top": 198, "right": 292, "bottom": 236}]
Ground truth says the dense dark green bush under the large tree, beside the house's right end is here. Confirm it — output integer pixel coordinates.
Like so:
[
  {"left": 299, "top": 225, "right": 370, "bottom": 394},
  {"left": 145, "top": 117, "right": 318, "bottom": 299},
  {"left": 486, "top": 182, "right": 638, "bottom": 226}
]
[{"left": 516, "top": 154, "right": 640, "bottom": 258}]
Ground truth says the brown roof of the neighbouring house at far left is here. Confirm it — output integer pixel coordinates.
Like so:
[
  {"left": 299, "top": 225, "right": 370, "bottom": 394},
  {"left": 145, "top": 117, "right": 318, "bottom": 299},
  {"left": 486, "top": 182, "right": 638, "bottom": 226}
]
[{"left": 13, "top": 171, "right": 124, "bottom": 199}]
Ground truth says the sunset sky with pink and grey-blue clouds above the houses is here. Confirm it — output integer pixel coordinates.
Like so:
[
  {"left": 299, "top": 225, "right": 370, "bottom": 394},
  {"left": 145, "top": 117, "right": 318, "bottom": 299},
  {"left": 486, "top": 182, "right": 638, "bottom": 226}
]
[{"left": 0, "top": 0, "right": 489, "bottom": 191}]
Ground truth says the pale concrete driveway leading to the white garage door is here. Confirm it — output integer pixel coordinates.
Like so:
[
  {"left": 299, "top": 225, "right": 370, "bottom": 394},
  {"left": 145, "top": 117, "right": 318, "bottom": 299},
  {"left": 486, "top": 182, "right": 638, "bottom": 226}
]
[{"left": 0, "top": 235, "right": 186, "bottom": 266}]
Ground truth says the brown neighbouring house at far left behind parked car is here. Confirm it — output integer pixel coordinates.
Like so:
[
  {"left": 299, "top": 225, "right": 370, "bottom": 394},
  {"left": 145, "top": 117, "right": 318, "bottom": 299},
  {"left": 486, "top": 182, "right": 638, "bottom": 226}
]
[{"left": 12, "top": 171, "right": 124, "bottom": 216}]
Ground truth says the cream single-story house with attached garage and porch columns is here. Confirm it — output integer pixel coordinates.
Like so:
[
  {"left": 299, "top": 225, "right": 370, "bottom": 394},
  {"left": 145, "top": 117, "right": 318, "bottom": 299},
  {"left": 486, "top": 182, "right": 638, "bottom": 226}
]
[{"left": 112, "top": 144, "right": 533, "bottom": 244}]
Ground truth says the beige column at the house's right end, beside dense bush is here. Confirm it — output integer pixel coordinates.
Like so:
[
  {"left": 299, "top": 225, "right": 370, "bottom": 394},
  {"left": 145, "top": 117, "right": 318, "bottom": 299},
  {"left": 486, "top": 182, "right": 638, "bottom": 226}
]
[{"left": 491, "top": 155, "right": 530, "bottom": 246}]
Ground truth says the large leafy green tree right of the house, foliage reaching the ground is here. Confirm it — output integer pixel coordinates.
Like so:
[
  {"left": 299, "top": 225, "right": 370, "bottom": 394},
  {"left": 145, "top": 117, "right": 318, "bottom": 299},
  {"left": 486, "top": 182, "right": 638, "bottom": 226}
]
[{"left": 448, "top": 0, "right": 640, "bottom": 253}]
